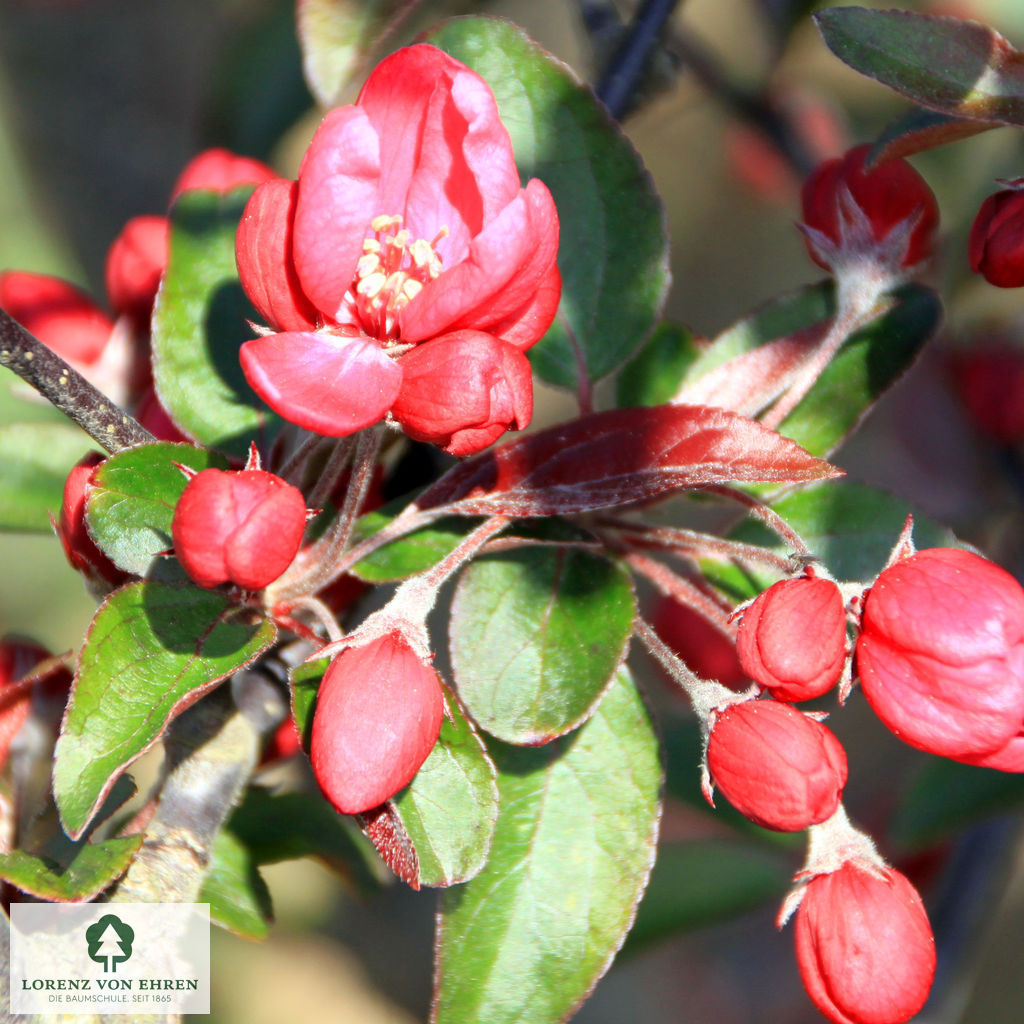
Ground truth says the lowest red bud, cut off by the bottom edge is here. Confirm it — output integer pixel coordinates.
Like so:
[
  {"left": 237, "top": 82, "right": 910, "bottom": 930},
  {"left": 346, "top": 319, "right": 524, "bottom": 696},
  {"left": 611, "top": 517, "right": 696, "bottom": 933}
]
[{"left": 796, "top": 860, "right": 935, "bottom": 1024}]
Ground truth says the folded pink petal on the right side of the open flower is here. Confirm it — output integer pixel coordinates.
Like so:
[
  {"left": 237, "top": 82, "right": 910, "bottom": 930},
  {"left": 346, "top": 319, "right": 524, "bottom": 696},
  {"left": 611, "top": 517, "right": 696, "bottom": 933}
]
[{"left": 401, "top": 179, "right": 560, "bottom": 348}]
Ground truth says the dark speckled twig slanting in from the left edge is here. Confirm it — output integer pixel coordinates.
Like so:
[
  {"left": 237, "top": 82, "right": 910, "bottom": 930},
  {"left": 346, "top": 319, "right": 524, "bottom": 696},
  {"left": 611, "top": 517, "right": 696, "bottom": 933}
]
[{"left": 0, "top": 309, "right": 157, "bottom": 455}]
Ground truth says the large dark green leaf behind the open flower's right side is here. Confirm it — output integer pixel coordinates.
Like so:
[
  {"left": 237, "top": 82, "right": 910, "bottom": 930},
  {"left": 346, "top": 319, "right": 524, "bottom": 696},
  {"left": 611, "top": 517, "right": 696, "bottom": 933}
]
[{"left": 427, "top": 24, "right": 669, "bottom": 389}]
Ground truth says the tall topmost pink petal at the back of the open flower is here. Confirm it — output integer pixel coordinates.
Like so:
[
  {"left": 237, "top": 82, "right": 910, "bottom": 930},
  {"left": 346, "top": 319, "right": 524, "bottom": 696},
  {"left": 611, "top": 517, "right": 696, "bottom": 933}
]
[{"left": 358, "top": 45, "right": 519, "bottom": 263}]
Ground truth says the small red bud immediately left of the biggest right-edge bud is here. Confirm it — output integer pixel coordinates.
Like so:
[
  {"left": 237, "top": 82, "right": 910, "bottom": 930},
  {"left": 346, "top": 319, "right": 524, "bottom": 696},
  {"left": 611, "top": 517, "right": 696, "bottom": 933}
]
[{"left": 736, "top": 577, "right": 846, "bottom": 700}]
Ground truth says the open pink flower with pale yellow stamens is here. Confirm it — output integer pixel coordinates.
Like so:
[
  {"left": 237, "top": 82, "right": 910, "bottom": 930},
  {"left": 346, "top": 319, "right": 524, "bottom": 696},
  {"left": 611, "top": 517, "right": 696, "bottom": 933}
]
[{"left": 237, "top": 45, "right": 561, "bottom": 446}]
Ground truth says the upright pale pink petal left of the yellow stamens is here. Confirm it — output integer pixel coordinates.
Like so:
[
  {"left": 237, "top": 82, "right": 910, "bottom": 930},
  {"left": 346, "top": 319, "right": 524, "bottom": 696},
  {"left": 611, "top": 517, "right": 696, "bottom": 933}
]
[{"left": 292, "top": 106, "right": 386, "bottom": 319}]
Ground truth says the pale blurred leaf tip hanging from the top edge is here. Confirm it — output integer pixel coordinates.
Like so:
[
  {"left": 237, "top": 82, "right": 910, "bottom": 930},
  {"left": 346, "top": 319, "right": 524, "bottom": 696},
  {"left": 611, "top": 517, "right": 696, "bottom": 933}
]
[{"left": 297, "top": 0, "right": 408, "bottom": 108}]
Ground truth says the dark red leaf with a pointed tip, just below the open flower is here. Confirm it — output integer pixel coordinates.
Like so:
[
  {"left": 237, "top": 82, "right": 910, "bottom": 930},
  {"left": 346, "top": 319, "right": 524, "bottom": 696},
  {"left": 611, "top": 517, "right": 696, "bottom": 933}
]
[{"left": 417, "top": 406, "right": 842, "bottom": 516}]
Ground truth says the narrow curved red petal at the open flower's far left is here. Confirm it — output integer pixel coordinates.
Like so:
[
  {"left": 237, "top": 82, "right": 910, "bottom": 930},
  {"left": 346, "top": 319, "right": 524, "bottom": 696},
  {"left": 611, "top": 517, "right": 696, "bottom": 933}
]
[{"left": 234, "top": 178, "right": 317, "bottom": 331}]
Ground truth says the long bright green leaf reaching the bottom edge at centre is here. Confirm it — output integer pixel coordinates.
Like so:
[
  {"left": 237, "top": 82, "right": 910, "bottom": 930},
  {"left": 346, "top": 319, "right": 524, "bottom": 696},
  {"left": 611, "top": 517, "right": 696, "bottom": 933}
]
[{"left": 432, "top": 669, "right": 662, "bottom": 1024}]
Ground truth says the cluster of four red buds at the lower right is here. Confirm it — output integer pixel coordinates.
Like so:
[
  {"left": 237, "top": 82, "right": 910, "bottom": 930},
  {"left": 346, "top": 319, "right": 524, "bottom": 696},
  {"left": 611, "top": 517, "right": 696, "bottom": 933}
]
[{"left": 652, "top": 534, "right": 1024, "bottom": 1024}]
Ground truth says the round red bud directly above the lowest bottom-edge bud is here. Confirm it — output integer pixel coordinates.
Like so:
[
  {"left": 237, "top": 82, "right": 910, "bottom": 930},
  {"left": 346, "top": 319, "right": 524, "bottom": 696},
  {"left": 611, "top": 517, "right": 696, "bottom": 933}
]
[{"left": 708, "top": 700, "right": 847, "bottom": 831}]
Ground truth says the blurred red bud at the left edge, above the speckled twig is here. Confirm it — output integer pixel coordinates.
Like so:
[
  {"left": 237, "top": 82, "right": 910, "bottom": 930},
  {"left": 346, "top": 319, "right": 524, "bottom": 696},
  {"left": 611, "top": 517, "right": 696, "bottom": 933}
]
[{"left": 0, "top": 270, "right": 114, "bottom": 368}]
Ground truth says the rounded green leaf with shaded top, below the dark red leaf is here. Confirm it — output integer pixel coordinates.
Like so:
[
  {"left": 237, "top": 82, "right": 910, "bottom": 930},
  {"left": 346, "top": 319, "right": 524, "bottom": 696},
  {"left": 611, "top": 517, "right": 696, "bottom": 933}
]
[{"left": 450, "top": 548, "right": 636, "bottom": 743}]
